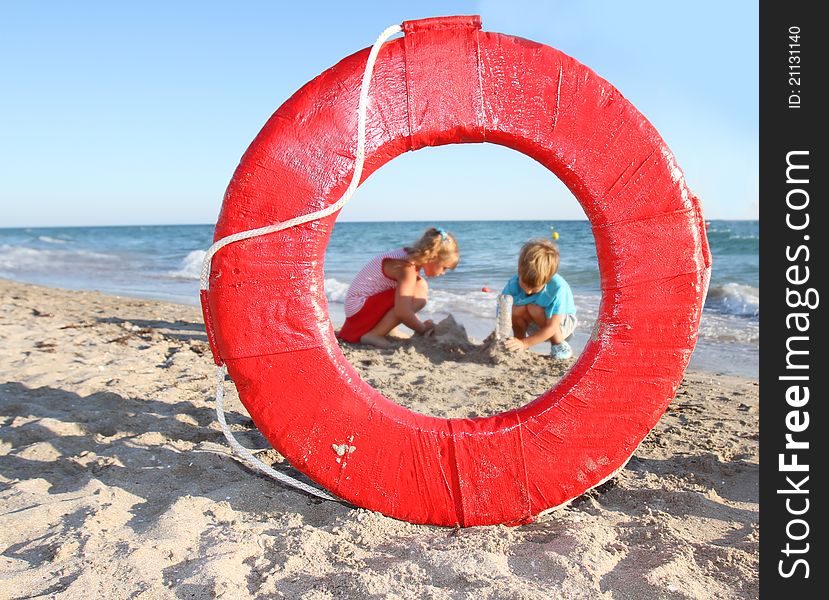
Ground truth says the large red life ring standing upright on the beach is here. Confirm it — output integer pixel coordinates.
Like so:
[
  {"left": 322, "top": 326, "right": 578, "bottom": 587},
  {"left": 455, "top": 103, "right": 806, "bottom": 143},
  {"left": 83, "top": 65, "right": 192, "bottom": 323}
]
[{"left": 205, "top": 17, "right": 711, "bottom": 526}]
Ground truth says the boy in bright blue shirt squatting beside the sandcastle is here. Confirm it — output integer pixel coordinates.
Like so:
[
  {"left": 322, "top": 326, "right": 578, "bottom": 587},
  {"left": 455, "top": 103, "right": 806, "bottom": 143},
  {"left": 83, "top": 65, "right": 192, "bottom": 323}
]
[{"left": 501, "top": 240, "right": 577, "bottom": 360}]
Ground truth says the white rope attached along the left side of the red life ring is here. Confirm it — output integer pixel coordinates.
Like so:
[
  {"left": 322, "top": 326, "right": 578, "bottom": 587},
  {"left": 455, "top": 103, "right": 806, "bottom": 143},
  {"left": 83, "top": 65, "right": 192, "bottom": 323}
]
[{"left": 204, "top": 25, "right": 402, "bottom": 501}]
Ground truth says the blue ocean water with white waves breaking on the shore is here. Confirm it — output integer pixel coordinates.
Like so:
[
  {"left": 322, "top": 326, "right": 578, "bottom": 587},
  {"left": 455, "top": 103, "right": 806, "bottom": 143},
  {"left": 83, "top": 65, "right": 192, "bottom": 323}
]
[{"left": 0, "top": 220, "right": 760, "bottom": 378}]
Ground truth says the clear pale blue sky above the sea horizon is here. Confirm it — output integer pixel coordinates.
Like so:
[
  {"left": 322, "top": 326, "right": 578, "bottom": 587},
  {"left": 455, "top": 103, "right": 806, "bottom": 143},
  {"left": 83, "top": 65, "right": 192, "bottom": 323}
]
[{"left": 0, "top": 0, "right": 759, "bottom": 227}]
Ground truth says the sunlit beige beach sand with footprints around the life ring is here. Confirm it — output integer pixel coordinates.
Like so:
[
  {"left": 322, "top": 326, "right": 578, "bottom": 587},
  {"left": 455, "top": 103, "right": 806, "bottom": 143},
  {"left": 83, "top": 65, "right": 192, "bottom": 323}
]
[{"left": 0, "top": 280, "right": 759, "bottom": 600}]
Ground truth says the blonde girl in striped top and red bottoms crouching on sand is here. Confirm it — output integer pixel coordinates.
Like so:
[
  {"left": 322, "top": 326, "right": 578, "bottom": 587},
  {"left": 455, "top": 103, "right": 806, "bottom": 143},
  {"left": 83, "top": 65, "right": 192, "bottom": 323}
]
[{"left": 337, "top": 227, "right": 460, "bottom": 348}]
